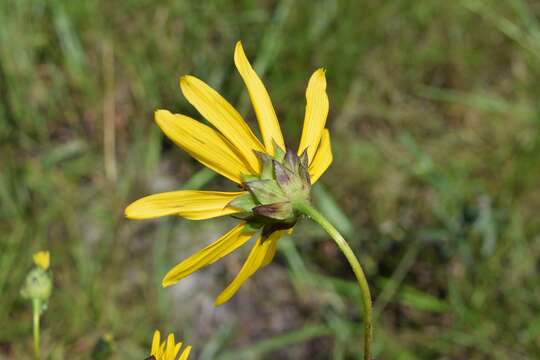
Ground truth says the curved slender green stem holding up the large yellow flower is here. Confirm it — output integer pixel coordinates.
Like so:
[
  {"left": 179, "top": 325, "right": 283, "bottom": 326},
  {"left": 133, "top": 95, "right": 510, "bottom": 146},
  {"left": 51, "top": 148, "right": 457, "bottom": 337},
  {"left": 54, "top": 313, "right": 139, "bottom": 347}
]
[{"left": 295, "top": 202, "right": 373, "bottom": 360}]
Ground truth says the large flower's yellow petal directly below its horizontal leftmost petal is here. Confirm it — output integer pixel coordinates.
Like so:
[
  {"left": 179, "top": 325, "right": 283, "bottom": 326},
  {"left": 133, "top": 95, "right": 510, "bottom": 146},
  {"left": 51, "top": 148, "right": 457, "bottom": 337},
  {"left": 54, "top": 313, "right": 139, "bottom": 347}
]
[{"left": 162, "top": 222, "right": 253, "bottom": 287}]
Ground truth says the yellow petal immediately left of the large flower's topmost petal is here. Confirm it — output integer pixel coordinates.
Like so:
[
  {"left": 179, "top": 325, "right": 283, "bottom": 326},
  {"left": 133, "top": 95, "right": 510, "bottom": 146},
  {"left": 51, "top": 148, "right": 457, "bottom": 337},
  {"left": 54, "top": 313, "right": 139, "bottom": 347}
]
[{"left": 180, "top": 75, "right": 264, "bottom": 173}]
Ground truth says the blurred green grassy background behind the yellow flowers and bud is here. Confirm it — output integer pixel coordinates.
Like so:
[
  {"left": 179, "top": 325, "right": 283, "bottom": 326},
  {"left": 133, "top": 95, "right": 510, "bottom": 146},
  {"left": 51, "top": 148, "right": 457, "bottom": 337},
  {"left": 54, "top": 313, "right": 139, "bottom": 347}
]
[{"left": 0, "top": 0, "right": 540, "bottom": 360}]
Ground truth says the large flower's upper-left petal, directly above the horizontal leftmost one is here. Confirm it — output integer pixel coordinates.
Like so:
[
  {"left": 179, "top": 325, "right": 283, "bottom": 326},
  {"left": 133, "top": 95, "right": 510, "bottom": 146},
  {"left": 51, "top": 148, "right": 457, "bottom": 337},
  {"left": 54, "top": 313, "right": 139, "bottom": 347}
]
[{"left": 155, "top": 110, "right": 253, "bottom": 183}]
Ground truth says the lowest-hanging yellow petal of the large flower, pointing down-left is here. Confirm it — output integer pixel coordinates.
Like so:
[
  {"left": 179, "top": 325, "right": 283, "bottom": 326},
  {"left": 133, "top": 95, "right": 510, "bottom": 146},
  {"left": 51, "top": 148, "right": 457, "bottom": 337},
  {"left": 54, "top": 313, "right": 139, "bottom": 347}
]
[{"left": 215, "top": 231, "right": 283, "bottom": 306}]
